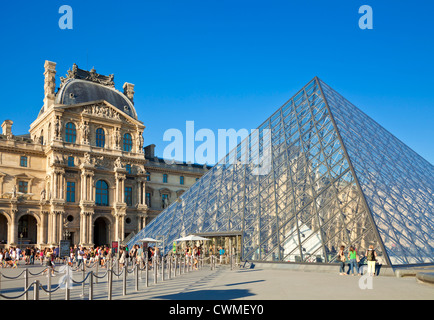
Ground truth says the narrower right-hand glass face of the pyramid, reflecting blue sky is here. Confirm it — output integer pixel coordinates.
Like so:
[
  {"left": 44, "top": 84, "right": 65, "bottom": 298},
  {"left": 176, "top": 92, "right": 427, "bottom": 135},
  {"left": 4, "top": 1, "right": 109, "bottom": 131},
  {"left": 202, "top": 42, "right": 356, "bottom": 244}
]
[{"left": 320, "top": 81, "right": 434, "bottom": 265}]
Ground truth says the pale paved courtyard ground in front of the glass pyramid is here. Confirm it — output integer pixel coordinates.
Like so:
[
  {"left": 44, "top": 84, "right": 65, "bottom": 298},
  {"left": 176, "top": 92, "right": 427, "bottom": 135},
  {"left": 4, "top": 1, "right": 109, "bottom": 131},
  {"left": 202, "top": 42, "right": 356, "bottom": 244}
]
[{"left": 0, "top": 265, "right": 434, "bottom": 300}]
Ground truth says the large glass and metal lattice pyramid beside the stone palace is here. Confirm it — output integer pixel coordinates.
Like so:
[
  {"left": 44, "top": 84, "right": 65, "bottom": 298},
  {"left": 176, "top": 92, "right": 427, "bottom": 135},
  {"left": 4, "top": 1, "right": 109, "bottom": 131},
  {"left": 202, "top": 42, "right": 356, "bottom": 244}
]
[{"left": 128, "top": 78, "right": 434, "bottom": 266}]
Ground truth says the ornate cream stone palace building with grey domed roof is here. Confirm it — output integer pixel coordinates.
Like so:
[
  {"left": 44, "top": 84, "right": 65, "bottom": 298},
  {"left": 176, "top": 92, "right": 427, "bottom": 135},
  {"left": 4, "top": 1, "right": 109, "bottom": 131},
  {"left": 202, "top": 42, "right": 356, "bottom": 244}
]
[{"left": 0, "top": 61, "right": 209, "bottom": 247}]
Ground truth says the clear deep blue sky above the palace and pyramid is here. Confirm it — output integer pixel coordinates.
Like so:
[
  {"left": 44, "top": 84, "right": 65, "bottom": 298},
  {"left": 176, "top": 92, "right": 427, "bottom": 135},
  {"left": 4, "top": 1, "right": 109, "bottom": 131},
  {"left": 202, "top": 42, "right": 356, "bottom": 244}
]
[{"left": 0, "top": 0, "right": 434, "bottom": 163}]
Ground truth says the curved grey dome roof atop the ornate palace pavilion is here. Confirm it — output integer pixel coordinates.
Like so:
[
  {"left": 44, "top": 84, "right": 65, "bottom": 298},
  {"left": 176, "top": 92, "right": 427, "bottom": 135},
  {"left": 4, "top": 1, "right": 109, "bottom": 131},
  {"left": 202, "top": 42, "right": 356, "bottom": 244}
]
[{"left": 55, "top": 79, "right": 137, "bottom": 120}]
